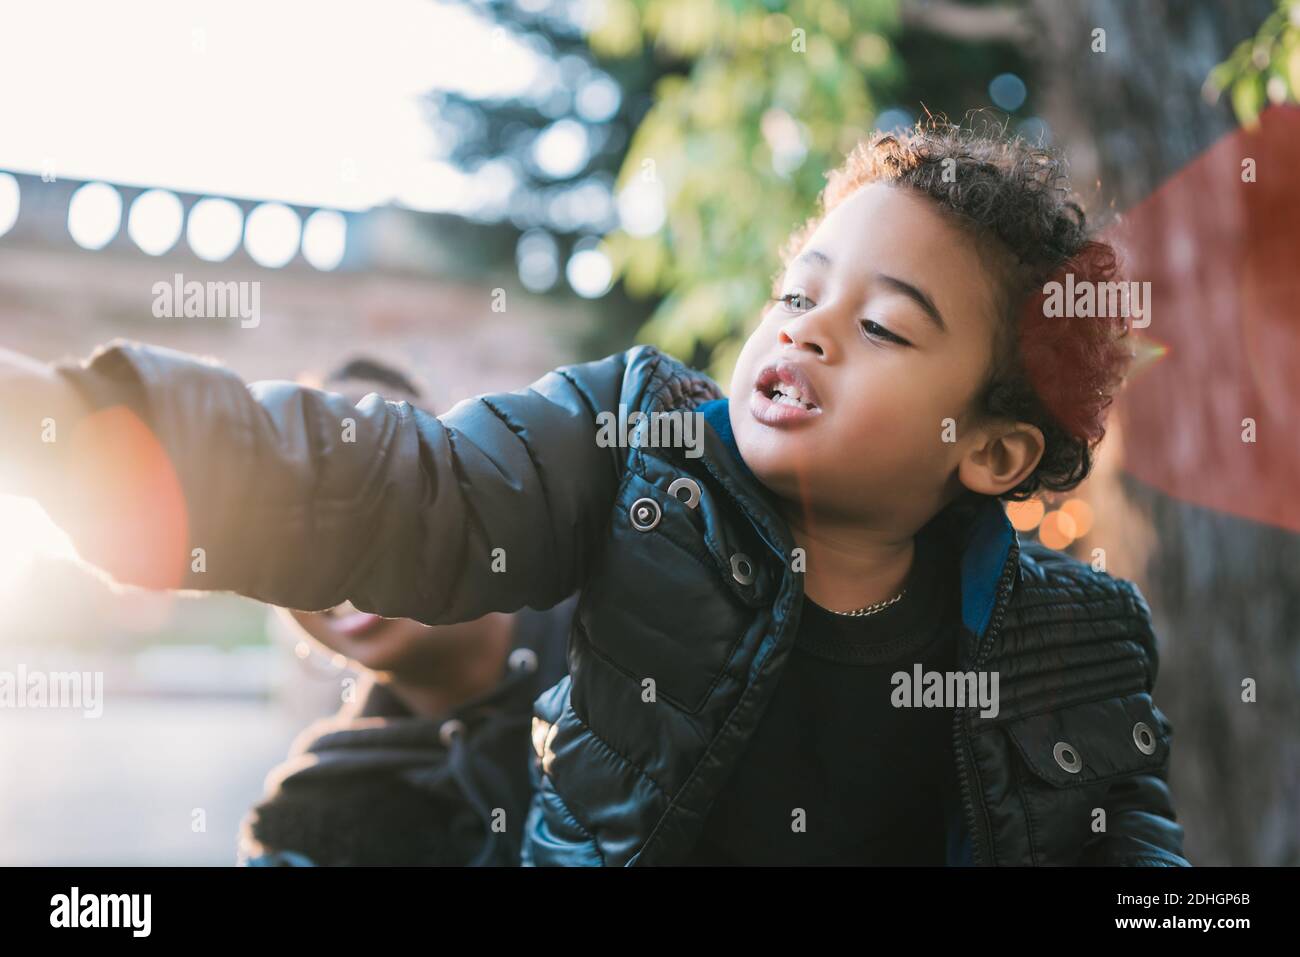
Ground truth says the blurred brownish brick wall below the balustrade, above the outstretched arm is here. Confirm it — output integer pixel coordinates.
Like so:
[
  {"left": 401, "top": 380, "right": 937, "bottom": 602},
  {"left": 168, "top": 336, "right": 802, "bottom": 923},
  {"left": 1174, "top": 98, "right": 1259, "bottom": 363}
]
[{"left": 0, "top": 239, "right": 594, "bottom": 411}]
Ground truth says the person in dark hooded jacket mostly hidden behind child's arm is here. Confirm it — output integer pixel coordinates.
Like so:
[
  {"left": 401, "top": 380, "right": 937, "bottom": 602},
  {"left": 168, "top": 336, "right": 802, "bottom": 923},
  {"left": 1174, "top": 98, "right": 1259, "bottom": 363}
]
[{"left": 238, "top": 358, "right": 576, "bottom": 866}]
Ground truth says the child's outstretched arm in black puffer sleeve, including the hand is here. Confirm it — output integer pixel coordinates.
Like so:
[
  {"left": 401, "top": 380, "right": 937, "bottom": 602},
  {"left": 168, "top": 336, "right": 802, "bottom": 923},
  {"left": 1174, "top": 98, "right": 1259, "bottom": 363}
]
[{"left": 0, "top": 343, "right": 627, "bottom": 624}]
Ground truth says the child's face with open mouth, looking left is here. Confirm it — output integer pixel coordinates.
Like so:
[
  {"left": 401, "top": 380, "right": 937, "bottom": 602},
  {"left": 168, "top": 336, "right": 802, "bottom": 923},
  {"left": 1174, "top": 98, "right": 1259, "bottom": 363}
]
[{"left": 731, "top": 183, "right": 998, "bottom": 528}]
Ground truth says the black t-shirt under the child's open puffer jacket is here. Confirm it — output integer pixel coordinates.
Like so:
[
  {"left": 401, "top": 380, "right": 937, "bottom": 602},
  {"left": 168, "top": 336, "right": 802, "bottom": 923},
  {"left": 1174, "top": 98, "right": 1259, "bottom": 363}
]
[{"left": 685, "top": 527, "right": 961, "bottom": 865}]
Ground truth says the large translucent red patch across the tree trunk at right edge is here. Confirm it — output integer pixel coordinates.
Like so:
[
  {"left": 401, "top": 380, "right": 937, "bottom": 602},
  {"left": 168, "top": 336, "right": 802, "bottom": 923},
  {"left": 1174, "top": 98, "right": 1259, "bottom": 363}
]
[{"left": 1117, "top": 107, "right": 1300, "bottom": 532}]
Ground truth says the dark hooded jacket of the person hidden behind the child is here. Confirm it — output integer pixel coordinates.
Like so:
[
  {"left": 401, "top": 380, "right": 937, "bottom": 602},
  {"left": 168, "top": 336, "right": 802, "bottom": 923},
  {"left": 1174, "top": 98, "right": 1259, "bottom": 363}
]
[{"left": 237, "top": 597, "right": 577, "bottom": 867}]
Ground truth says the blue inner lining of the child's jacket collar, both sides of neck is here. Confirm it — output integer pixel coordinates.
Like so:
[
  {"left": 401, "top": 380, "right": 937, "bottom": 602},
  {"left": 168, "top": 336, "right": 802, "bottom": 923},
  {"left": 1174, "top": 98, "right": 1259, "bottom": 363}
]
[{"left": 697, "top": 398, "right": 1015, "bottom": 644}]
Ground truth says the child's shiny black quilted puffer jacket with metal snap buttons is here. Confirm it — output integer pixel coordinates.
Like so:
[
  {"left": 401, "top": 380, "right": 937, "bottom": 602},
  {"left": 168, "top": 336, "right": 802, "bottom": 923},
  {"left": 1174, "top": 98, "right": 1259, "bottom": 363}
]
[{"left": 58, "top": 345, "right": 1187, "bottom": 866}]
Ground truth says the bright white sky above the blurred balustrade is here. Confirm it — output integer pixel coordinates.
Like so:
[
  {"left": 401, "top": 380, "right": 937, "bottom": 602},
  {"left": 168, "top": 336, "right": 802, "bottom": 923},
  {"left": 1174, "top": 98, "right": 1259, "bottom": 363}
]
[{"left": 0, "top": 0, "right": 550, "bottom": 211}]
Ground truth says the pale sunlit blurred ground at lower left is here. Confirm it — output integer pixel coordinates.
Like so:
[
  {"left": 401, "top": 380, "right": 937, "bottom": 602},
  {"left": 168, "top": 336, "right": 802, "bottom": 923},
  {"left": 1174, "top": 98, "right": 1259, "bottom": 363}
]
[{"left": 0, "top": 698, "right": 303, "bottom": 865}]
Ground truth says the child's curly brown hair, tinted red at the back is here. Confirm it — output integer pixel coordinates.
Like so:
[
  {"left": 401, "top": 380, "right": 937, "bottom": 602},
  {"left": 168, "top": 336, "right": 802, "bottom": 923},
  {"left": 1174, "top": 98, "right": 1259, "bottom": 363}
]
[{"left": 783, "top": 117, "right": 1134, "bottom": 501}]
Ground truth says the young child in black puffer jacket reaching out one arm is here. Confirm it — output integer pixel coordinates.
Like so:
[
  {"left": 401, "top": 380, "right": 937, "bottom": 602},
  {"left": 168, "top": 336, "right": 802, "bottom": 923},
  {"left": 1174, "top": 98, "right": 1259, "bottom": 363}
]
[{"left": 0, "top": 125, "right": 1187, "bottom": 866}]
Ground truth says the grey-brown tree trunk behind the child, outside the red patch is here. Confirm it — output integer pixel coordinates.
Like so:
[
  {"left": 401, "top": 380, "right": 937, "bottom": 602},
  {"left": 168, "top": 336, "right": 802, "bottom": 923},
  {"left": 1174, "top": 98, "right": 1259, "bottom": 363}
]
[{"left": 1031, "top": 0, "right": 1300, "bottom": 865}]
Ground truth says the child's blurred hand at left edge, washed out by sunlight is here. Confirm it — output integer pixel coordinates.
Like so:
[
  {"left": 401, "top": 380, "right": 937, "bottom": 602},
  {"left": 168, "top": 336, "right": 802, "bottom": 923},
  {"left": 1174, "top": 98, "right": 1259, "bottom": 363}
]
[{"left": 0, "top": 348, "right": 90, "bottom": 497}]
